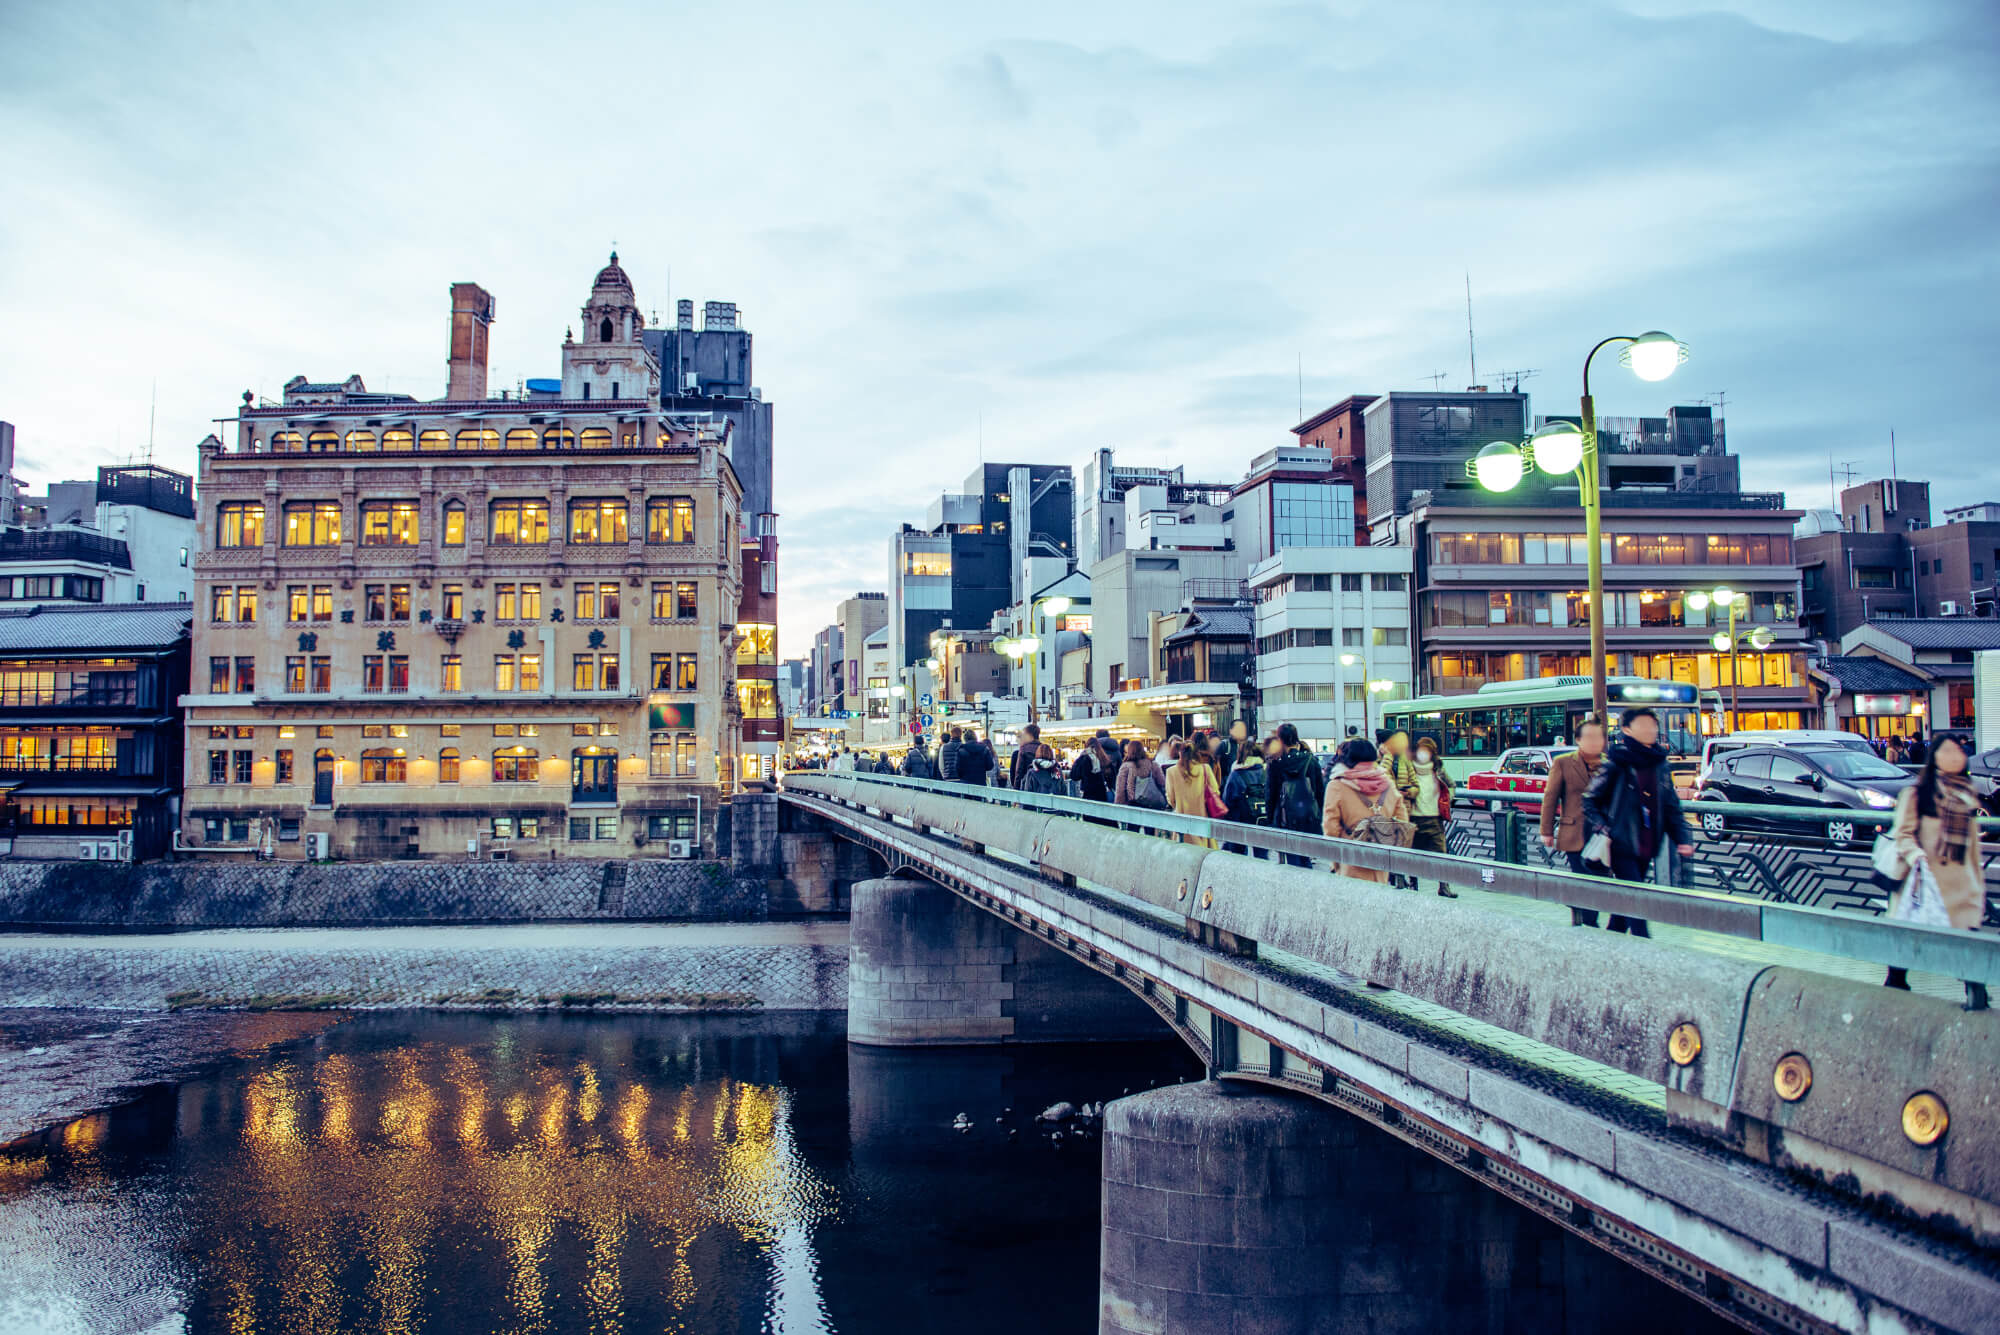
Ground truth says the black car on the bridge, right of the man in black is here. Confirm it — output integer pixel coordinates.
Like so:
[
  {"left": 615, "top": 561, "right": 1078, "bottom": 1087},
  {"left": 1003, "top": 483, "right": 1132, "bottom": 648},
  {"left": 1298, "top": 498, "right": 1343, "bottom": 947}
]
[{"left": 1702, "top": 743, "right": 1916, "bottom": 843}]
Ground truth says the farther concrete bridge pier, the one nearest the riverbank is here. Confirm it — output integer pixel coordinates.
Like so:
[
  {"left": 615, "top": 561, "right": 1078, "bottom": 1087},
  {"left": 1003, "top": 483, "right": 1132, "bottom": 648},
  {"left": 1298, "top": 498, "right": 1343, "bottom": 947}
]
[{"left": 848, "top": 875, "right": 1170, "bottom": 1047}]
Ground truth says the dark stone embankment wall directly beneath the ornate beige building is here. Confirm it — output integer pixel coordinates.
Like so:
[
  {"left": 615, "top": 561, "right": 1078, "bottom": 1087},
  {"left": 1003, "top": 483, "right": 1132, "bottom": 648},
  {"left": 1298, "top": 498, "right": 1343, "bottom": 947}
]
[{"left": 0, "top": 857, "right": 770, "bottom": 929}]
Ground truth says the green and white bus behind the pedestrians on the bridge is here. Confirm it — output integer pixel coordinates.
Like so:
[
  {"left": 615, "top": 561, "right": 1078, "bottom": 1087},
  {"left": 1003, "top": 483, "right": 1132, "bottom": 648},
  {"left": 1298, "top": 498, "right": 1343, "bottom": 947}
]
[{"left": 1382, "top": 677, "right": 1702, "bottom": 783}]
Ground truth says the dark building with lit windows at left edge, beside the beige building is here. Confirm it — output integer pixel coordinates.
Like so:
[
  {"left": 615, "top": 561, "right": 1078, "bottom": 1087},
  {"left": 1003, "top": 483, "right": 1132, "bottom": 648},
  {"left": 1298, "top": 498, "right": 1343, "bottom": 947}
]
[{"left": 0, "top": 602, "right": 189, "bottom": 859}]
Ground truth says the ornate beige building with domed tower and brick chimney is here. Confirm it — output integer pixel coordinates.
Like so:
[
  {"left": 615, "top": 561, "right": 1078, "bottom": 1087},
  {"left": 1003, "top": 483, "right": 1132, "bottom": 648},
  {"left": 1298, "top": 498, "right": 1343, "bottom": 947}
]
[{"left": 182, "top": 256, "right": 742, "bottom": 857}]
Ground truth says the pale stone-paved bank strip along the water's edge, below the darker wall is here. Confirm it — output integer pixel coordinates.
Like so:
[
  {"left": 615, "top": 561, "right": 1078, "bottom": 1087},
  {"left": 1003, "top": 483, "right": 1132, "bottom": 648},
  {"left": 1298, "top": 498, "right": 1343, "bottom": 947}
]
[{"left": 0, "top": 923, "right": 848, "bottom": 1011}]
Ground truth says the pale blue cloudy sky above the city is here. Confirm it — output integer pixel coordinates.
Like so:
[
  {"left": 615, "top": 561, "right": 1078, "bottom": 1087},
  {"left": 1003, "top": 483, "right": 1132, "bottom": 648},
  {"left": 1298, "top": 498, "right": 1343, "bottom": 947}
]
[{"left": 0, "top": 0, "right": 2000, "bottom": 656}]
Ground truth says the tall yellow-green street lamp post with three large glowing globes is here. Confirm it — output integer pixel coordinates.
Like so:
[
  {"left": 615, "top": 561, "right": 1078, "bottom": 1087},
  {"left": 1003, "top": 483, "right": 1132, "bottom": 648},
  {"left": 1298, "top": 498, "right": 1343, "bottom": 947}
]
[{"left": 1466, "top": 330, "right": 1688, "bottom": 731}]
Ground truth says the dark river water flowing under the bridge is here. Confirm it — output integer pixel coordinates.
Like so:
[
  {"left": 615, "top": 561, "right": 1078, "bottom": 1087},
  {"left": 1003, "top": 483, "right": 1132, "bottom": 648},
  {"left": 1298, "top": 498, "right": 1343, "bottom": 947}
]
[{"left": 0, "top": 1013, "right": 1720, "bottom": 1335}]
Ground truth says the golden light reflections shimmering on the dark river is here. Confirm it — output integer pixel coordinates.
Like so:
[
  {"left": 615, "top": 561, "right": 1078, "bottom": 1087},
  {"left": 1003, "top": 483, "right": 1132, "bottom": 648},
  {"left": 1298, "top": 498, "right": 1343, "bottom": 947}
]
[{"left": 162, "top": 1035, "right": 834, "bottom": 1335}]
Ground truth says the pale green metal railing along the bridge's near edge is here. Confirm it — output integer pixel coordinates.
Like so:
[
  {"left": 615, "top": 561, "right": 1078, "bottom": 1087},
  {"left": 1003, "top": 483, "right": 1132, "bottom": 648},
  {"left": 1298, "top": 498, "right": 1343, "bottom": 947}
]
[{"left": 788, "top": 773, "right": 2000, "bottom": 1005}]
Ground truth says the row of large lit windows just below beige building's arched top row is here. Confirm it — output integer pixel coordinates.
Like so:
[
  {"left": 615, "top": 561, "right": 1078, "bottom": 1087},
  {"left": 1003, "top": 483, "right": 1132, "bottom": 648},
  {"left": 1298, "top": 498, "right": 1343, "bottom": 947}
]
[{"left": 216, "top": 496, "right": 694, "bottom": 548}]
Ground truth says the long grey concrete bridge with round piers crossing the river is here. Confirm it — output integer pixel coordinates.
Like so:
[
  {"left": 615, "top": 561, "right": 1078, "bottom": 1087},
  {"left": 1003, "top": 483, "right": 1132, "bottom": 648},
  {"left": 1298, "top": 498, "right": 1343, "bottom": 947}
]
[{"left": 780, "top": 775, "right": 2000, "bottom": 1333}]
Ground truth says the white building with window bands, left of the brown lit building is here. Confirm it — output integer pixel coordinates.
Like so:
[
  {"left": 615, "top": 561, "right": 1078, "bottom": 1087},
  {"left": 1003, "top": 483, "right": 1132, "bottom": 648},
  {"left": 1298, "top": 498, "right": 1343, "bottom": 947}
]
[{"left": 1250, "top": 548, "right": 1416, "bottom": 749}]
